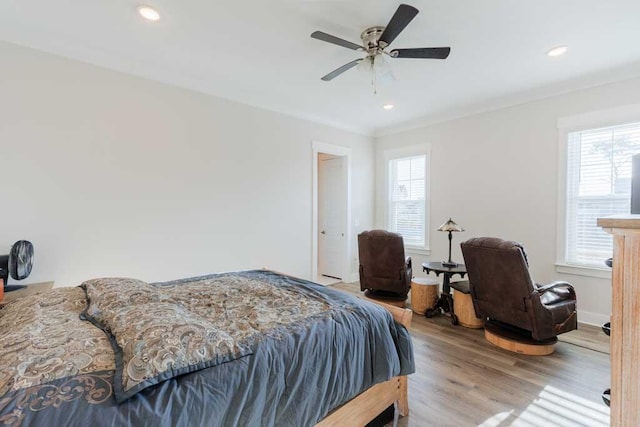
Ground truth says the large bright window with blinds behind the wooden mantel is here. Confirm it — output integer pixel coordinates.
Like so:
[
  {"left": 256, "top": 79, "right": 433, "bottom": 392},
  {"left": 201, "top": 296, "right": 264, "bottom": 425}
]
[{"left": 565, "top": 123, "right": 640, "bottom": 267}]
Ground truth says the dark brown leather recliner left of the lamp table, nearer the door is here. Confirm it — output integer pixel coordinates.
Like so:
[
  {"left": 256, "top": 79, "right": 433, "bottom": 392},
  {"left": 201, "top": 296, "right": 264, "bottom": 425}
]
[{"left": 358, "top": 230, "right": 413, "bottom": 300}]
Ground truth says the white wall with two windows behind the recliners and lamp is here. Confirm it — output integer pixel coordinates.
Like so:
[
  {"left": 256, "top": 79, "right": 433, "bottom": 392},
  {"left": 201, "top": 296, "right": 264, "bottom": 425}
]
[{"left": 376, "top": 79, "right": 640, "bottom": 323}]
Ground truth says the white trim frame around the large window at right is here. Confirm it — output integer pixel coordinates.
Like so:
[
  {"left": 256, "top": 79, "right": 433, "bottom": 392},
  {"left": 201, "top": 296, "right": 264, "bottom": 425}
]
[{"left": 555, "top": 104, "right": 640, "bottom": 279}]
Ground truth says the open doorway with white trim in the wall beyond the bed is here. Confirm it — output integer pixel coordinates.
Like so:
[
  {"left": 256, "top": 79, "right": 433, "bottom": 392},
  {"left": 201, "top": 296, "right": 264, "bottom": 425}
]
[{"left": 312, "top": 142, "right": 351, "bottom": 285}]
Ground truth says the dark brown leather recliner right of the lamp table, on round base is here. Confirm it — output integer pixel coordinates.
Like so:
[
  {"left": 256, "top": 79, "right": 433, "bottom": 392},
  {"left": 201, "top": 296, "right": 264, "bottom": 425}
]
[{"left": 460, "top": 237, "right": 578, "bottom": 341}]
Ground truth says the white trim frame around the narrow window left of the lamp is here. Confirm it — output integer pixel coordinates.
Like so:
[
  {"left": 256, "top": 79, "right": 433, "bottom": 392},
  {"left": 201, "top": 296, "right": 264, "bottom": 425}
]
[{"left": 383, "top": 144, "right": 431, "bottom": 255}]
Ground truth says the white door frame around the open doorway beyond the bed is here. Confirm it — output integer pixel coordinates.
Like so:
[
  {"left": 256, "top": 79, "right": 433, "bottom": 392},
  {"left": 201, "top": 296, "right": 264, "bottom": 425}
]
[{"left": 311, "top": 141, "right": 356, "bottom": 282}]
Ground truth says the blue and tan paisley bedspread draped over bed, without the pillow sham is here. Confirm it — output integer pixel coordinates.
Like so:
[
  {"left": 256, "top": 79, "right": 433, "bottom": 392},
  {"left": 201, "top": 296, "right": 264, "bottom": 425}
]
[{"left": 0, "top": 271, "right": 415, "bottom": 427}]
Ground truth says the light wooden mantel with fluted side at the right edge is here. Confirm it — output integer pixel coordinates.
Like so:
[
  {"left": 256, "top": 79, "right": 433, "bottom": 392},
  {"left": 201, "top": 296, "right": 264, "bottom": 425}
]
[{"left": 598, "top": 215, "right": 640, "bottom": 427}]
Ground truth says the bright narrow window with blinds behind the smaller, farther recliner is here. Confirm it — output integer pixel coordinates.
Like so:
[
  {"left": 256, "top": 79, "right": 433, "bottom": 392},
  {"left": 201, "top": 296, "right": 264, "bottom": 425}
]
[{"left": 388, "top": 155, "right": 427, "bottom": 248}]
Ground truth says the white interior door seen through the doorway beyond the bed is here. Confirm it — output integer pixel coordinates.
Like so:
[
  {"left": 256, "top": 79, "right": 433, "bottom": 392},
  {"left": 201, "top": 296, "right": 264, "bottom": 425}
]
[{"left": 318, "top": 157, "right": 347, "bottom": 279}]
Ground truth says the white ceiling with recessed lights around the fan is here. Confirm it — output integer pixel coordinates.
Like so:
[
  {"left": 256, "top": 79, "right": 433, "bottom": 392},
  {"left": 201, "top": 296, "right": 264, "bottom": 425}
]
[{"left": 0, "top": 0, "right": 640, "bottom": 134}]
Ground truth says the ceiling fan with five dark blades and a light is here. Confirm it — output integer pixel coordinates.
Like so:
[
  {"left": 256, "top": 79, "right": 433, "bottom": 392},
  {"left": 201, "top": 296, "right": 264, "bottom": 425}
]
[{"left": 311, "top": 4, "right": 451, "bottom": 86}]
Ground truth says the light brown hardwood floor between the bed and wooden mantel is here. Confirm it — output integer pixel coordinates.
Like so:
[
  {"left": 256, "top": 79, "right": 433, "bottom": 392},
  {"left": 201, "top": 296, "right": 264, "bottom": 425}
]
[{"left": 333, "top": 283, "right": 610, "bottom": 427}]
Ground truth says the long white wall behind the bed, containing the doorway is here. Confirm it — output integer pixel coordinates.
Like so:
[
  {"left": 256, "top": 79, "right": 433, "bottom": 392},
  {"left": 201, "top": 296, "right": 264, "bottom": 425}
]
[{"left": 0, "top": 43, "right": 375, "bottom": 286}]
